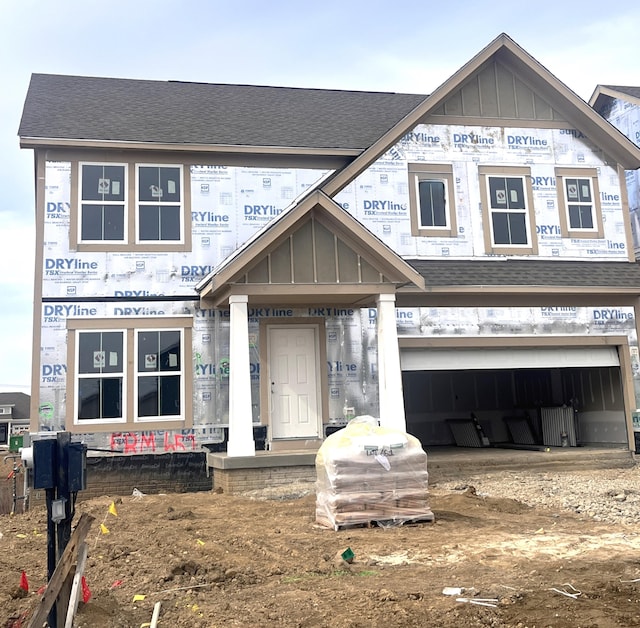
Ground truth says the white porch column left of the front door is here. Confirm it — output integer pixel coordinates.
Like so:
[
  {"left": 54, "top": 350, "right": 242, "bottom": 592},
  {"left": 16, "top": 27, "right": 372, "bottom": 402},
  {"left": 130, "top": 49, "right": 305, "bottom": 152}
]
[{"left": 227, "top": 294, "right": 256, "bottom": 456}]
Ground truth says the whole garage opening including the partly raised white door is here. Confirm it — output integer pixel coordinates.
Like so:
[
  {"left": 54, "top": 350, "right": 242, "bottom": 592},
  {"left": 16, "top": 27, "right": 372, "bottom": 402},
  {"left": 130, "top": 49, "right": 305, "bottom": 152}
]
[{"left": 401, "top": 347, "right": 628, "bottom": 448}]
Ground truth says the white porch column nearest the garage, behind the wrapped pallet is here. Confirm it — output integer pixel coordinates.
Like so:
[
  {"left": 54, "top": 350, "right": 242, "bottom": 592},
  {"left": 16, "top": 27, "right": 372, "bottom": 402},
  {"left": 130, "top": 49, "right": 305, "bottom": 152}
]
[{"left": 376, "top": 294, "right": 407, "bottom": 432}]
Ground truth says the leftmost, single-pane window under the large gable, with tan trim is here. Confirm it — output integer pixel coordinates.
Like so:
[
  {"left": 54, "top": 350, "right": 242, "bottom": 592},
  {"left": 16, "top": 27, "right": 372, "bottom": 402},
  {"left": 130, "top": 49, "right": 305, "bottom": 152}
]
[{"left": 409, "top": 163, "right": 457, "bottom": 237}]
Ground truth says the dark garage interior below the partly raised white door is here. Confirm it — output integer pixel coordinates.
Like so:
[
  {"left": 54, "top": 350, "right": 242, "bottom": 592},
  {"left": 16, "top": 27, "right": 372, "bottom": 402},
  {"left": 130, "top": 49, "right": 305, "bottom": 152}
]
[{"left": 402, "top": 367, "right": 628, "bottom": 449}]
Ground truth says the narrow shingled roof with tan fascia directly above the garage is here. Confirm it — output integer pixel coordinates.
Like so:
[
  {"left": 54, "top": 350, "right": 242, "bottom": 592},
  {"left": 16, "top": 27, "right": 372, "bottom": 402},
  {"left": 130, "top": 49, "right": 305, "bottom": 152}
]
[{"left": 398, "top": 258, "right": 640, "bottom": 306}]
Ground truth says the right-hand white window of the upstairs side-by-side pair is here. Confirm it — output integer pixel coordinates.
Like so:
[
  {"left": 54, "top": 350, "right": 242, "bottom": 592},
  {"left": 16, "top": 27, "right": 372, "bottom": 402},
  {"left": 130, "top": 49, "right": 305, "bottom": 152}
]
[{"left": 136, "top": 164, "right": 184, "bottom": 242}]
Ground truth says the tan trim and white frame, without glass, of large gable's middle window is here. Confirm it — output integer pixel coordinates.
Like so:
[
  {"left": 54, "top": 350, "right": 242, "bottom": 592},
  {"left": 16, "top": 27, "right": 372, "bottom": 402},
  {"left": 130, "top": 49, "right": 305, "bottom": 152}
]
[{"left": 478, "top": 166, "right": 538, "bottom": 255}]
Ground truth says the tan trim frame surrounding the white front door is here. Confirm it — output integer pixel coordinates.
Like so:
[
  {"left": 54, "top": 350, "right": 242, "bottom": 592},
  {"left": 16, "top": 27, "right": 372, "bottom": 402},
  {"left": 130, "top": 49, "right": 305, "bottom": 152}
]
[{"left": 259, "top": 316, "right": 329, "bottom": 442}]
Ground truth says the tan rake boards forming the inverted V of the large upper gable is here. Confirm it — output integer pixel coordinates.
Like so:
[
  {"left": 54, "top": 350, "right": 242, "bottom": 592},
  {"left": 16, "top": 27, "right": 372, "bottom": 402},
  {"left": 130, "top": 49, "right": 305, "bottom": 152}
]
[{"left": 323, "top": 33, "right": 640, "bottom": 196}]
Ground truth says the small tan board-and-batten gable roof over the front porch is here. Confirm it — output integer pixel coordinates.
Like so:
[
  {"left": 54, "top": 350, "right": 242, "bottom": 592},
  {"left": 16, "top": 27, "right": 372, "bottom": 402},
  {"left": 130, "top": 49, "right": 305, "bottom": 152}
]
[{"left": 196, "top": 190, "right": 424, "bottom": 306}]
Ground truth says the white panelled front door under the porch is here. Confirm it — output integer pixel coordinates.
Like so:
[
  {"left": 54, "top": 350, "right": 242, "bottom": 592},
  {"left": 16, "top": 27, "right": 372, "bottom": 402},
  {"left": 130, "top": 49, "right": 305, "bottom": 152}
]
[{"left": 268, "top": 325, "right": 322, "bottom": 439}]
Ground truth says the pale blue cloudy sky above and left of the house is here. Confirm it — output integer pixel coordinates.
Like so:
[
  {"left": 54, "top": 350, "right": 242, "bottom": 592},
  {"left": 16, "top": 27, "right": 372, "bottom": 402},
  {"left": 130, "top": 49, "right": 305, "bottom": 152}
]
[{"left": 0, "top": 0, "right": 640, "bottom": 394}]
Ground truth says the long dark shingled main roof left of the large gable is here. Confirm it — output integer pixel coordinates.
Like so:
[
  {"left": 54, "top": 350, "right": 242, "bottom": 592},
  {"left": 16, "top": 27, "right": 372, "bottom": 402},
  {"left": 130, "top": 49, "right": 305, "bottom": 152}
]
[{"left": 19, "top": 74, "right": 425, "bottom": 151}]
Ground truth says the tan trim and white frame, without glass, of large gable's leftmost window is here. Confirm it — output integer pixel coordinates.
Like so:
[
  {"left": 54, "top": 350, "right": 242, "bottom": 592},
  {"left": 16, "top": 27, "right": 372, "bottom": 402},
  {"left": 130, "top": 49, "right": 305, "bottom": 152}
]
[{"left": 408, "top": 162, "right": 458, "bottom": 238}]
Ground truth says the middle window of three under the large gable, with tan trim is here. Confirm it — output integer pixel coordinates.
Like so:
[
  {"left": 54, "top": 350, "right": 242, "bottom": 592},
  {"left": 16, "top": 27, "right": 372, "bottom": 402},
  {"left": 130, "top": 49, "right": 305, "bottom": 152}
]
[{"left": 478, "top": 166, "right": 537, "bottom": 255}]
